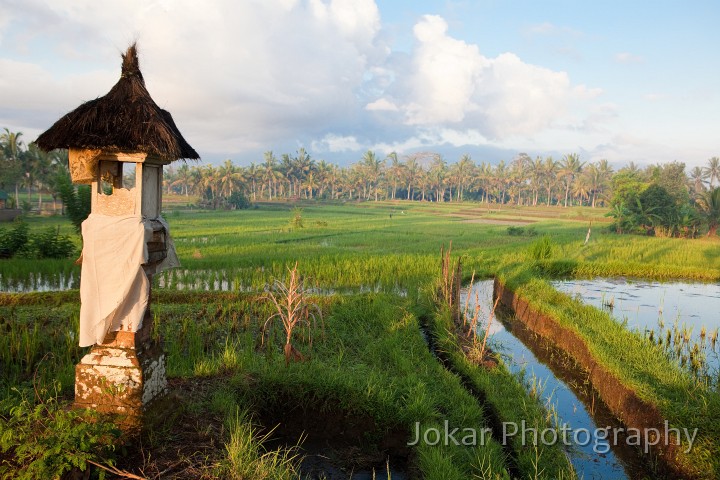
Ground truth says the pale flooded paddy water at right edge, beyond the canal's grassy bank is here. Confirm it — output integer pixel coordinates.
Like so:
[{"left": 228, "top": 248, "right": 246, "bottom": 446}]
[{"left": 551, "top": 278, "right": 720, "bottom": 375}]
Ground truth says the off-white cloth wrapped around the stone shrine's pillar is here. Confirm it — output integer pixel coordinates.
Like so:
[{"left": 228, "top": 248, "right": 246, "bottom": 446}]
[{"left": 80, "top": 214, "right": 179, "bottom": 347}]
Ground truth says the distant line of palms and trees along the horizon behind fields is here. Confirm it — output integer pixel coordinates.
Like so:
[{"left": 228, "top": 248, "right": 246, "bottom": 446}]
[{"left": 0, "top": 128, "right": 720, "bottom": 236}]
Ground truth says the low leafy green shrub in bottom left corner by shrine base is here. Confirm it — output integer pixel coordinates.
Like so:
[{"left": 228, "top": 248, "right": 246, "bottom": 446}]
[{"left": 0, "top": 385, "right": 120, "bottom": 480}]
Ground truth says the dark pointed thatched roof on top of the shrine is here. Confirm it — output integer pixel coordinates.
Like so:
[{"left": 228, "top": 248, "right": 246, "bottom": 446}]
[{"left": 35, "top": 44, "right": 200, "bottom": 161}]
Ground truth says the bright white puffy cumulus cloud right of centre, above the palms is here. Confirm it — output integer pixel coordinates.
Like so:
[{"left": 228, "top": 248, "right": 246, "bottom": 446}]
[{"left": 382, "top": 15, "right": 601, "bottom": 139}]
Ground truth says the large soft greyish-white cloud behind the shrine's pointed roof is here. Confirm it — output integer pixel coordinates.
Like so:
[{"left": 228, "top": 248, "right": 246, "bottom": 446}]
[{"left": 0, "top": 0, "right": 385, "bottom": 151}]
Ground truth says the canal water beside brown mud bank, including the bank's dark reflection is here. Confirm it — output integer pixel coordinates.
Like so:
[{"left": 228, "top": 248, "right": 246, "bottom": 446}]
[{"left": 462, "top": 280, "right": 654, "bottom": 480}]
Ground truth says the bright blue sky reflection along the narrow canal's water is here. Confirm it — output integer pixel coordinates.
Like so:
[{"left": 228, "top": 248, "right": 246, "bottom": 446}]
[{"left": 461, "top": 280, "right": 631, "bottom": 480}]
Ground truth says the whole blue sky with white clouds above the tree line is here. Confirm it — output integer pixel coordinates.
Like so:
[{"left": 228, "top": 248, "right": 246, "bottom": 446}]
[{"left": 0, "top": 0, "right": 720, "bottom": 170}]
